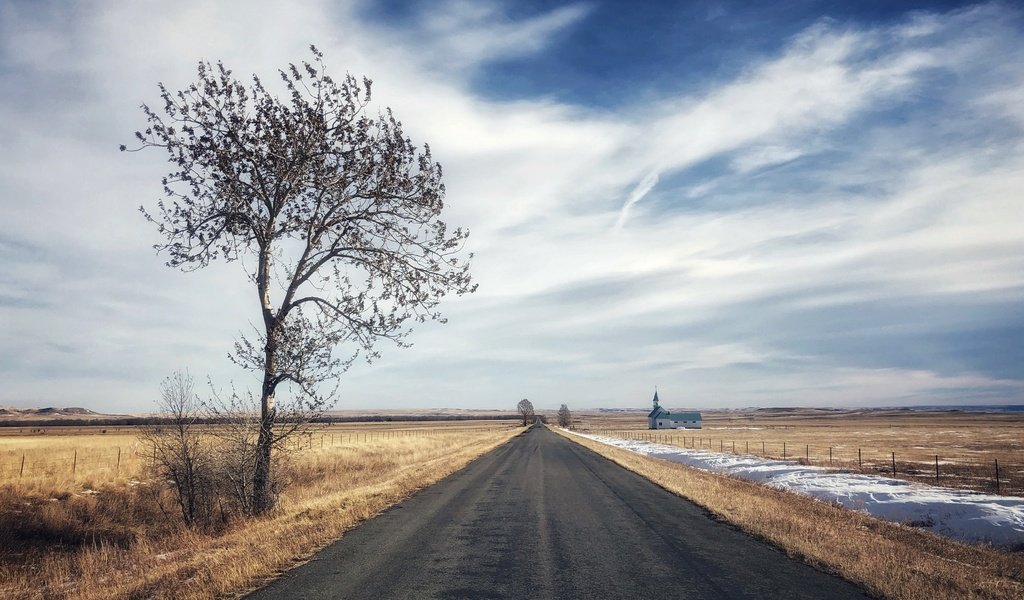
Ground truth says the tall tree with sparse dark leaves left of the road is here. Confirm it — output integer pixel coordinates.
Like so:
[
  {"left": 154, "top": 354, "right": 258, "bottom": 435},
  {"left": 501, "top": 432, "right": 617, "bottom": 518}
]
[{"left": 128, "top": 47, "right": 475, "bottom": 513}]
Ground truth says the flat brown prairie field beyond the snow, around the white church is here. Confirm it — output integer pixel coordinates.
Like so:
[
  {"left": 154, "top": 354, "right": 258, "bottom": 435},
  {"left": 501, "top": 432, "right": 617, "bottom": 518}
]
[{"left": 578, "top": 409, "right": 1024, "bottom": 496}]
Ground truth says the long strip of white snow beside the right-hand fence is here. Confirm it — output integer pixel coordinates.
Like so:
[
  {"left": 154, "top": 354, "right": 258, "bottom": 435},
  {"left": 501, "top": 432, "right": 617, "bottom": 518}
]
[{"left": 570, "top": 432, "right": 1024, "bottom": 548}]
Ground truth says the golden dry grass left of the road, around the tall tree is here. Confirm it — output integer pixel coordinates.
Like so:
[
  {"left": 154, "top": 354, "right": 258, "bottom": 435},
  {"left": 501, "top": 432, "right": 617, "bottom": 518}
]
[{"left": 0, "top": 424, "right": 521, "bottom": 599}]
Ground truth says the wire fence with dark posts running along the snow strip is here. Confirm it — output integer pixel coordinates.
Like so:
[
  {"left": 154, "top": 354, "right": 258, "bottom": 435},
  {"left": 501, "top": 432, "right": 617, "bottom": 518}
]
[{"left": 590, "top": 430, "right": 1024, "bottom": 496}]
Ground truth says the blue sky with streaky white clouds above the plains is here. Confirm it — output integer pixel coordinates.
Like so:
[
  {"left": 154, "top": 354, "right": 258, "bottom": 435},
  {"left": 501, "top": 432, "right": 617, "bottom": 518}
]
[{"left": 0, "top": 0, "right": 1024, "bottom": 413}]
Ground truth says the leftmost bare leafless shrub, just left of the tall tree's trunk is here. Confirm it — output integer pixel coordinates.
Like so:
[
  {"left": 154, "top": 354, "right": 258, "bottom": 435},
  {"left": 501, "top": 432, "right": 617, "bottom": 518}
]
[{"left": 139, "top": 371, "right": 215, "bottom": 526}]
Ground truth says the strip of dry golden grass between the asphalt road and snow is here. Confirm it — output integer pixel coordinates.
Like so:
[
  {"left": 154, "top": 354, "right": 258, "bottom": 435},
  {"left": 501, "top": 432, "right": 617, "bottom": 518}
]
[{"left": 556, "top": 430, "right": 1024, "bottom": 600}]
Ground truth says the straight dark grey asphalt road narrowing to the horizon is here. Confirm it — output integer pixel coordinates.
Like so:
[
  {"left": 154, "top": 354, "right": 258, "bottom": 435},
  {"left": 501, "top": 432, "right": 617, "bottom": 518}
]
[{"left": 249, "top": 426, "right": 866, "bottom": 600}]
